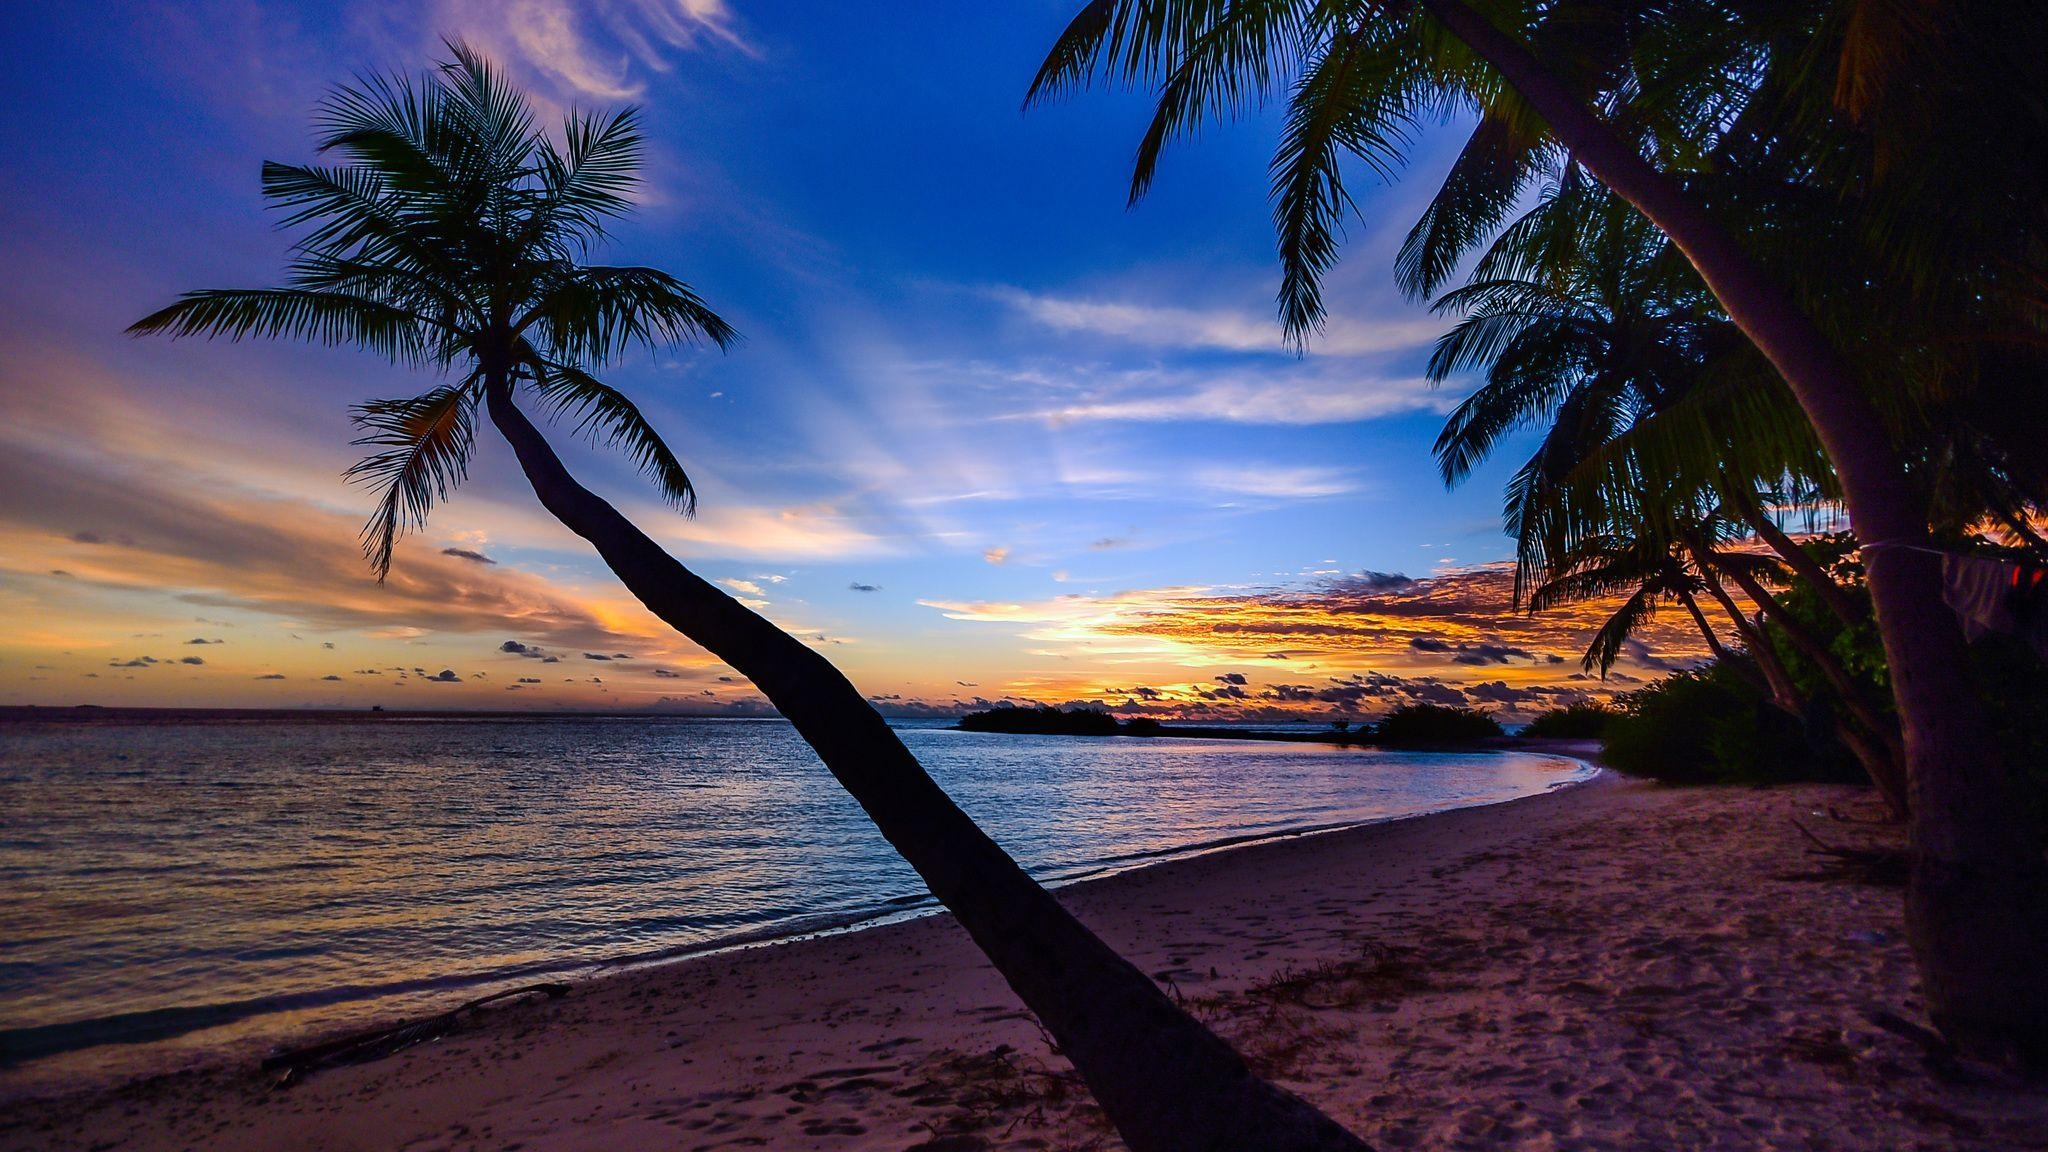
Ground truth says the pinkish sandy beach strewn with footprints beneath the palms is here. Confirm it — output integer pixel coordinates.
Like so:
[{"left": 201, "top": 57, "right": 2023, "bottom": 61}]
[{"left": 0, "top": 775, "right": 2048, "bottom": 1152}]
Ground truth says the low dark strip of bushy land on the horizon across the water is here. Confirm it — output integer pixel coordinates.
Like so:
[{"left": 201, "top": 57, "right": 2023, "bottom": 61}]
[{"left": 958, "top": 703, "right": 1507, "bottom": 748}]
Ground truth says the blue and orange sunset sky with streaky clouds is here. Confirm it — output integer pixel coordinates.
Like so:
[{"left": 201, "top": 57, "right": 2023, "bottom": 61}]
[{"left": 0, "top": 0, "right": 1700, "bottom": 717}]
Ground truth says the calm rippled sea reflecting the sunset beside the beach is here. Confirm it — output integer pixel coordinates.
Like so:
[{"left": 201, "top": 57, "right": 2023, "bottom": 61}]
[{"left": 0, "top": 719, "right": 1587, "bottom": 1070}]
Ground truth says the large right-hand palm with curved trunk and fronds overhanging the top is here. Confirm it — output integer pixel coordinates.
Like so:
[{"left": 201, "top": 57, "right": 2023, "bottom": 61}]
[{"left": 1028, "top": 0, "right": 2048, "bottom": 1062}]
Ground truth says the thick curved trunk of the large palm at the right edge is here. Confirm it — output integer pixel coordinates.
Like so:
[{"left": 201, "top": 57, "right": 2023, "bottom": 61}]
[{"left": 1421, "top": 0, "right": 2048, "bottom": 1064}]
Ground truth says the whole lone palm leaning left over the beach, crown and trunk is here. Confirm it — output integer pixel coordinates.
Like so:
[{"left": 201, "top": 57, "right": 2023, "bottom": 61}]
[{"left": 131, "top": 45, "right": 1364, "bottom": 1152}]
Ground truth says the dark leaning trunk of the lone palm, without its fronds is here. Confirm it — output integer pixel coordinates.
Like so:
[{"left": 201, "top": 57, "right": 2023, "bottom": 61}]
[{"left": 487, "top": 385, "right": 1366, "bottom": 1152}]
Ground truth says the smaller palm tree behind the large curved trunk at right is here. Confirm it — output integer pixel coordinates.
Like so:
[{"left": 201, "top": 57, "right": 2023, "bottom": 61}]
[{"left": 1430, "top": 181, "right": 1909, "bottom": 818}]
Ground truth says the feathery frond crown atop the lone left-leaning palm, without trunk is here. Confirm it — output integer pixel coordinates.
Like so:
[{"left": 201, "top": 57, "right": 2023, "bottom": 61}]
[{"left": 129, "top": 43, "right": 737, "bottom": 580}]
